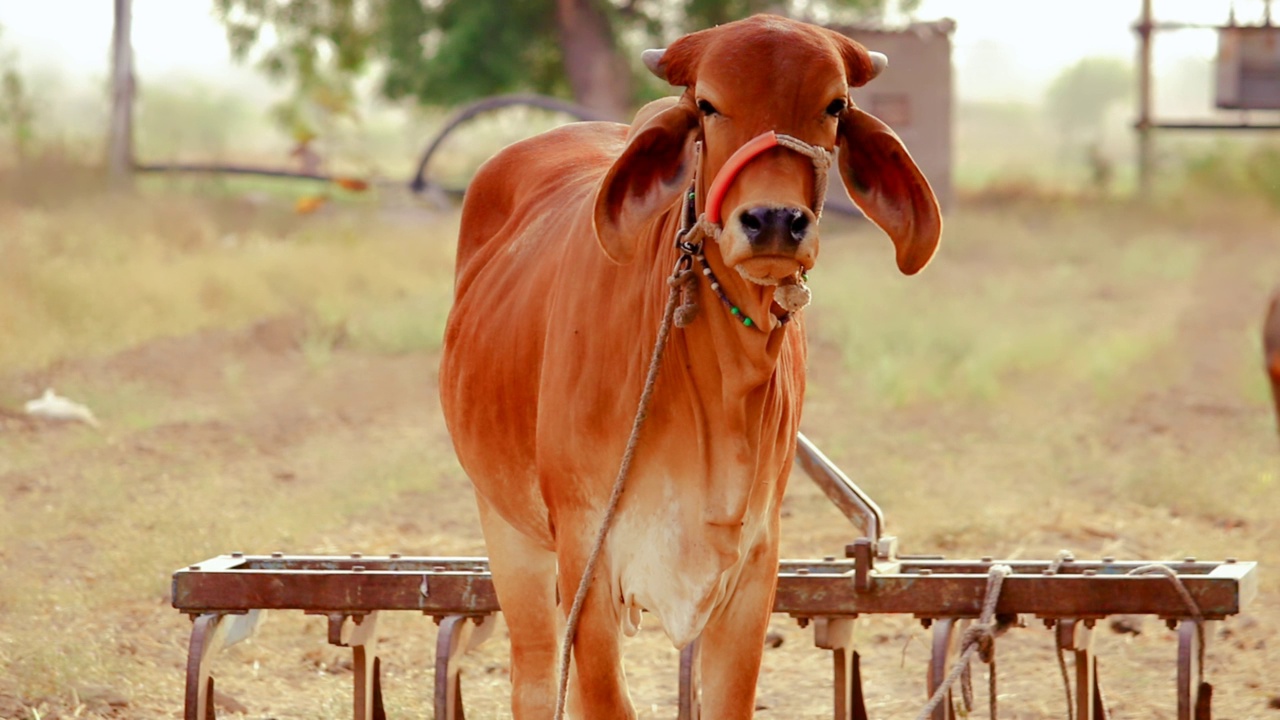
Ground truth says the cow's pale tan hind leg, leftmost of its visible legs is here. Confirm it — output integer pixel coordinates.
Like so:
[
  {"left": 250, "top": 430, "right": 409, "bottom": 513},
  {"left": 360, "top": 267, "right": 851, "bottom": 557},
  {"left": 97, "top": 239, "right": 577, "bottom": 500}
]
[{"left": 476, "top": 495, "right": 559, "bottom": 720}]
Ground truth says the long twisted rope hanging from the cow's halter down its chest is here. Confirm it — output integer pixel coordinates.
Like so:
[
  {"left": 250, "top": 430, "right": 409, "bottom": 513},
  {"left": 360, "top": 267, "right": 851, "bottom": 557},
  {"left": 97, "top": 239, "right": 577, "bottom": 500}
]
[{"left": 556, "top": 258, "right": 694, "bottom": 720}]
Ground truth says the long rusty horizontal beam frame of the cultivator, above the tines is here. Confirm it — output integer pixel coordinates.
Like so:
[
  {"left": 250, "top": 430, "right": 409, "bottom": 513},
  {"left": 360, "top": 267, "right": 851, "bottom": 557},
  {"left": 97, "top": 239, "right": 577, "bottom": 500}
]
[{"left": 173, "top": 557, "right": 1257, "bottom": 620}]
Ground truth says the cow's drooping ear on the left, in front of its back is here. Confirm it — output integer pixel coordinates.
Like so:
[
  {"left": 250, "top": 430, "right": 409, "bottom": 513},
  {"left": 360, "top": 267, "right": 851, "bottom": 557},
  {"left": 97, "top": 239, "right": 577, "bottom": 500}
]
[{"left": 593, "top": 96, "right": 699, "bottom": 264}]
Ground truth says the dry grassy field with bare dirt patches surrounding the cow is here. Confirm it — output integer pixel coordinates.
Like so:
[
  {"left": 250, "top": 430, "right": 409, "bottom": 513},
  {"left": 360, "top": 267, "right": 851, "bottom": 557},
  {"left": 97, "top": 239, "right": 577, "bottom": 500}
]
[{"left": 0, "top": 176, "right": 1280, "bottom": 720}]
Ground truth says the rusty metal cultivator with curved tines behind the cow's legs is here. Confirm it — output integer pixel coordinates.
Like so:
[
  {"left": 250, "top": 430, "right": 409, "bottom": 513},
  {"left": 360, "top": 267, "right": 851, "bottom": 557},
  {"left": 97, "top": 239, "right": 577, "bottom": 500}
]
[{"left": 173, "top": 436, "right": 1257, "bottom": 720}]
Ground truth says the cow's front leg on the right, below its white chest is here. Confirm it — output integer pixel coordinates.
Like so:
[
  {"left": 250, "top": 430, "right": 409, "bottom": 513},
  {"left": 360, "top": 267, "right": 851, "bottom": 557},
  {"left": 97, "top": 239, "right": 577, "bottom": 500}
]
[{"left": 699, "top": 534, "right": 778, "bottom": 720}]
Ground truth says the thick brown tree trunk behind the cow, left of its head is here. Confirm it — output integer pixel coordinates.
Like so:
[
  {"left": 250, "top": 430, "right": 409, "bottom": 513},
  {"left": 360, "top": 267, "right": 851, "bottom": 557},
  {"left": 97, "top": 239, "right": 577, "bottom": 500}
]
[{"left": 556, "top": 0, "right": 631, "bottom": 120}]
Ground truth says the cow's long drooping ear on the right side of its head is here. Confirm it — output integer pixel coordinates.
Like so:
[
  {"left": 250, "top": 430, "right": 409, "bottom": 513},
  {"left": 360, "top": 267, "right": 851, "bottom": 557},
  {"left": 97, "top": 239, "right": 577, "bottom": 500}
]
[{"left": 838, "top": 106, "right": 942, "bottom": 275}]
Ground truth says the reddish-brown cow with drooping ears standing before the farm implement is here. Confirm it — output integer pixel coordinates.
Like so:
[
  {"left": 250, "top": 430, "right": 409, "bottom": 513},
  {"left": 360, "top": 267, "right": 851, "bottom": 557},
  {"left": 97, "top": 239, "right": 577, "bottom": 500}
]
[{"left": 439, "top": 15, "right": 942, "bottom": 720}]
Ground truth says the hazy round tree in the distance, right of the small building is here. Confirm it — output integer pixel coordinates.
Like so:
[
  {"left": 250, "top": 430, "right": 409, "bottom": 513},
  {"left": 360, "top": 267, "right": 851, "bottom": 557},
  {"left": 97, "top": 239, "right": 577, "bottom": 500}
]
[{"left": 1044, "top": 58, "right": 1133, "bottom": 142}]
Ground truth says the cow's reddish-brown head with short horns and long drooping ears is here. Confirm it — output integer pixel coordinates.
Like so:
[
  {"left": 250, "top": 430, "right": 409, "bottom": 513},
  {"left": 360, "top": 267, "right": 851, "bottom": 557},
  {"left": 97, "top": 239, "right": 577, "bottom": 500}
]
[{"left": 595, "top": 15, "right": 942, "bottom": 278}]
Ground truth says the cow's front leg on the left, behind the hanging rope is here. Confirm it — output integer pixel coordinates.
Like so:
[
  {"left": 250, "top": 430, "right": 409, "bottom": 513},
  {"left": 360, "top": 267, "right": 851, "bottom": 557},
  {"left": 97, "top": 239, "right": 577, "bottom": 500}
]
[{"left": 558, "top": 523, "right": 635, "bottom": 720}]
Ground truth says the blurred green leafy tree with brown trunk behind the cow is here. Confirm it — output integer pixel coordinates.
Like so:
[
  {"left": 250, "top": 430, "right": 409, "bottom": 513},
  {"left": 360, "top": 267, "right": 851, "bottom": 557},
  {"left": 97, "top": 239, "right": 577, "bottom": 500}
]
[{"left": 215, "top": 0, "right": 919, "bottom": 118}]
